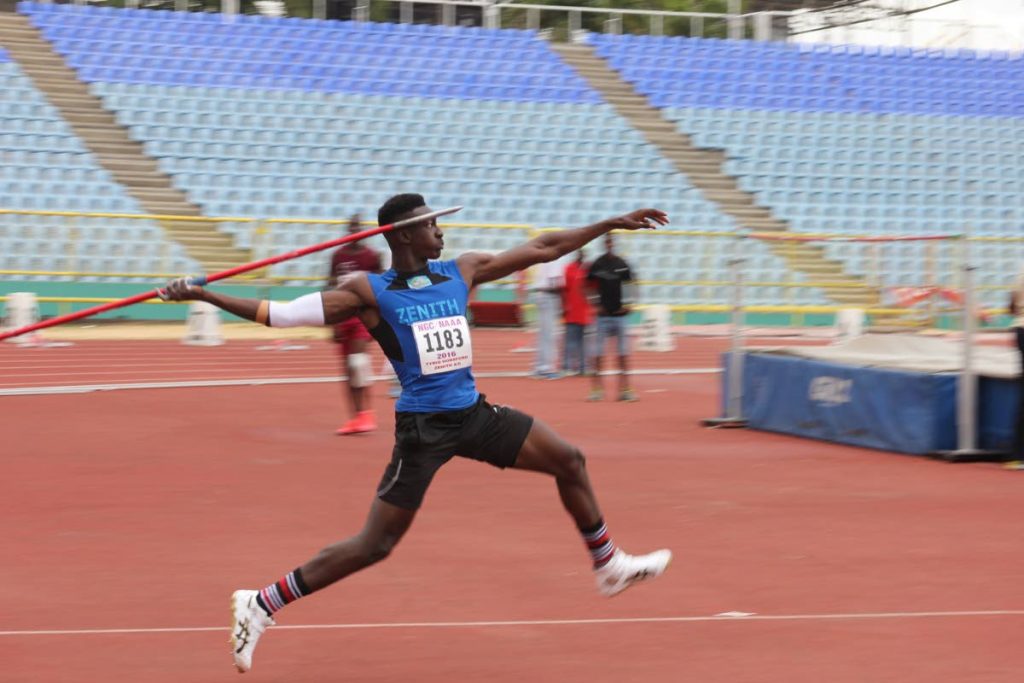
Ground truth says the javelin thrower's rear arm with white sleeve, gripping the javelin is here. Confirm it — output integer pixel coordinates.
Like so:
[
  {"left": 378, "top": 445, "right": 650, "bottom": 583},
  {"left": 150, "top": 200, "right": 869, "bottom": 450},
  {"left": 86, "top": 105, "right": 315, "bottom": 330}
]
[{"left": 162, "top": 278, "right": 364, "bottom": 328}]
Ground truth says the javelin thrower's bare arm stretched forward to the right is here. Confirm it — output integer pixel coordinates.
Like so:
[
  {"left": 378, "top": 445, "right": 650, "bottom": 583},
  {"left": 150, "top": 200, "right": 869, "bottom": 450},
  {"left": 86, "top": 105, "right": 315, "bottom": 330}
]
[{"left": 458, "top": 209, "right": 669, "bottom": 286}]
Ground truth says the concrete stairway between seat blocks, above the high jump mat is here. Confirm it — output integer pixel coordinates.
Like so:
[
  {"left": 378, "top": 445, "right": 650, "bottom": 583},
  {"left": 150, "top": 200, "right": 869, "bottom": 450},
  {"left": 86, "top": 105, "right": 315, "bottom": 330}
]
[{"left": 551, "top": 43, "right": 881, "bottom": 307}]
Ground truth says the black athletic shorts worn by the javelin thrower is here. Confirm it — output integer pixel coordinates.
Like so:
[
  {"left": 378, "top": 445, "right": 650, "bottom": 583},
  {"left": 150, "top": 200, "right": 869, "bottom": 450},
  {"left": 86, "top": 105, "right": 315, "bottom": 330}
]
[{"left": 377, "top": 394, "right": 534, "bottom": 510}]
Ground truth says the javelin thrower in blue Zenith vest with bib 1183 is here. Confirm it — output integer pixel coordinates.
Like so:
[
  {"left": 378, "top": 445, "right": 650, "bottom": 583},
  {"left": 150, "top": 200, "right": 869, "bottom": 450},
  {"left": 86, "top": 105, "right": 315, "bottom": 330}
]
[{"left": 164, "top": 195, "right": 672, "bottom": 672}]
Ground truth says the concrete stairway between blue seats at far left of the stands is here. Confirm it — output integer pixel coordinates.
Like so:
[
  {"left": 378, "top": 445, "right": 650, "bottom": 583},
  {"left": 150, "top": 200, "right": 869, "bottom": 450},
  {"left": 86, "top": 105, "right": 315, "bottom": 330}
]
[{"left": 0, "top": 11, "right": 250, "bottom": 272}]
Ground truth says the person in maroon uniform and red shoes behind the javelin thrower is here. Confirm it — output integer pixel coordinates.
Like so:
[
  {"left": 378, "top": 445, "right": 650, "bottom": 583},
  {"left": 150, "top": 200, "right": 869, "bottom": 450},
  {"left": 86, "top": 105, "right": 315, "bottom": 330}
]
[{"left": 328, "top": 214, "right": 381, "bottom": 435}]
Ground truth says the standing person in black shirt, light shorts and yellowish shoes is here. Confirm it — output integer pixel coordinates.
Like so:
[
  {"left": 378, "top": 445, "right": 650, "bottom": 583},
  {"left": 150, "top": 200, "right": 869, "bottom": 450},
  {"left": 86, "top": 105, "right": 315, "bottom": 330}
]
[{"left": 587, "top": 232, "right": 637, "bottom": 400}]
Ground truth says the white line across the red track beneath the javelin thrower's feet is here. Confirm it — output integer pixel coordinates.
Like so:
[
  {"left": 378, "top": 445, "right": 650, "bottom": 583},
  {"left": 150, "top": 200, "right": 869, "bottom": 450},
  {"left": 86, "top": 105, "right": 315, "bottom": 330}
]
[{"left": 0, "top": 609, "right": 1024, "bottom": 637}]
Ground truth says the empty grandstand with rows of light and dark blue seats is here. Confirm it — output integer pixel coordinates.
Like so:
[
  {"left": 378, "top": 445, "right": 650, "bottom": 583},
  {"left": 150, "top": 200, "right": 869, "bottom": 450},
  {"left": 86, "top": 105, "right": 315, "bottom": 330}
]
[{"left": 0, "top": 2, "right": 1024, "bottom": 317}]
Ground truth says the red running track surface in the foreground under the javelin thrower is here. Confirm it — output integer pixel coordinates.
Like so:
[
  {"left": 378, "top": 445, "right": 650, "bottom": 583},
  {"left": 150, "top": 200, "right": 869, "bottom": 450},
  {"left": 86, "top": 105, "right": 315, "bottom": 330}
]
[{"left": 0, "top": 370, "right": 1024, "bottom": 683}]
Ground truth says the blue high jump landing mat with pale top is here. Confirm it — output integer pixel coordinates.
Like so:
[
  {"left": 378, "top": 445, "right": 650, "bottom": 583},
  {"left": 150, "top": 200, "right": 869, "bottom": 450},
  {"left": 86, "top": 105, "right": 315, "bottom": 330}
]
[{"left": 722, "top": 335, "right": 1020, "bottom": 455}]
